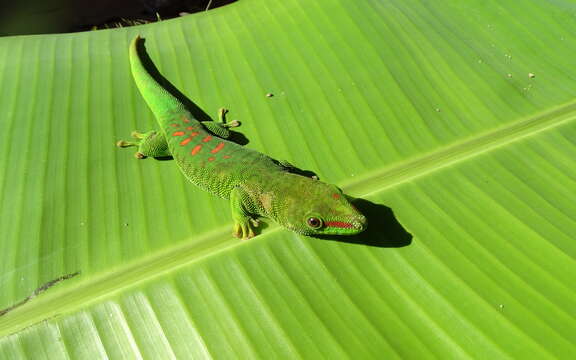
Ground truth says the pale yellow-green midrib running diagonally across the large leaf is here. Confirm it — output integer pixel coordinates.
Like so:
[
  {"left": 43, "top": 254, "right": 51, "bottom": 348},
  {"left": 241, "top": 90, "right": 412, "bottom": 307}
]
[{"left": 0, "top": 101, "right": 576, "bottom": 337}]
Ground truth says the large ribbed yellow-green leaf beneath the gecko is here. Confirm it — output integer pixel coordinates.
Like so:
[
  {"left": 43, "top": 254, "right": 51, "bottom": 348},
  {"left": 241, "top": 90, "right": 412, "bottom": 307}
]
[{"left": 0, "top": 0, "right": 576, "bottom": 359}]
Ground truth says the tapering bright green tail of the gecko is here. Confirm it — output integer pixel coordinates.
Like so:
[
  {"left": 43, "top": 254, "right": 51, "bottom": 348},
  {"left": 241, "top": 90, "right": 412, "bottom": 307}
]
[{"left": 129, "top": 35, "right": 188, "bottom": 127}]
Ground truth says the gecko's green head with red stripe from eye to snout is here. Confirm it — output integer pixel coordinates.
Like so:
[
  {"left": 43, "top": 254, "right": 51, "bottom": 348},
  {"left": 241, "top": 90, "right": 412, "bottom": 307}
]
[{"left": 279, "top": 177, "right": 367, "bottom": 235}]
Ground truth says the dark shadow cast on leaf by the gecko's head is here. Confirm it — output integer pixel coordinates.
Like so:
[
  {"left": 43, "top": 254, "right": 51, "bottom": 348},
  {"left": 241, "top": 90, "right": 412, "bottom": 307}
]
[{"left": 318, "top": 199, "right": 412, "bottom": 248}]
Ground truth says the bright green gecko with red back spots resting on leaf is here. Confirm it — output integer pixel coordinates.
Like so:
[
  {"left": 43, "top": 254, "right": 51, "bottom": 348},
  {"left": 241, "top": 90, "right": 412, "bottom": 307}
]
[{"left": 117, "top": 36, "right": 367, "bottom": 239}]
